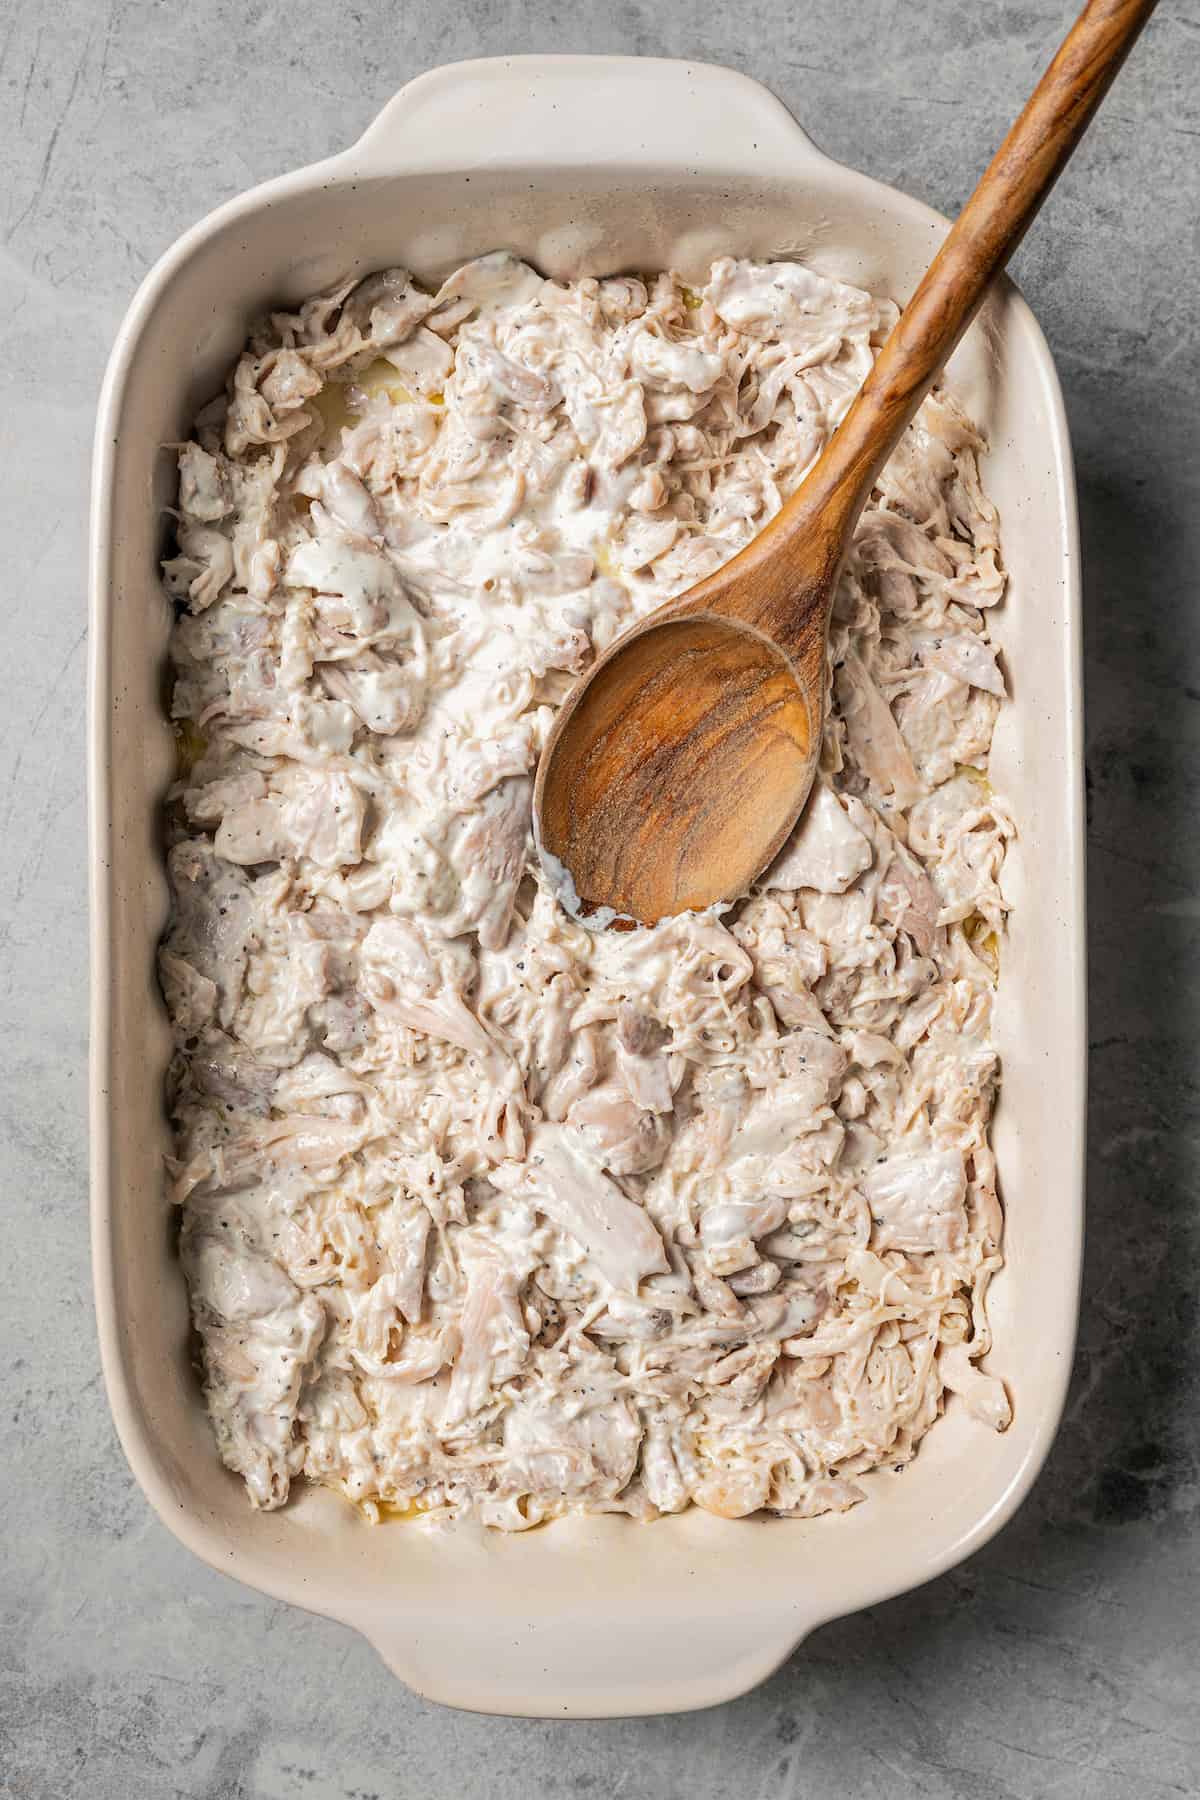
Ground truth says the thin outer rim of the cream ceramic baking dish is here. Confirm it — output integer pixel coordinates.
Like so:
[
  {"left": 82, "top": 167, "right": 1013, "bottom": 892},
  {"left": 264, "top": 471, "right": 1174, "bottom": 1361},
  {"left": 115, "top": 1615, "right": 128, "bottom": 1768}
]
[{"left": 88, "top": 56, "right": 1087, "bottom": 1715}]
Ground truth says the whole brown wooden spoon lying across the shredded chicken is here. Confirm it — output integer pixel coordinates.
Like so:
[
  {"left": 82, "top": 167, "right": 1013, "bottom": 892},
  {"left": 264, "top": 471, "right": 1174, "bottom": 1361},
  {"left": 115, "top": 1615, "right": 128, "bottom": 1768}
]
[{"left": 534, "top": 0, "right": 1155, "bottom": 925}]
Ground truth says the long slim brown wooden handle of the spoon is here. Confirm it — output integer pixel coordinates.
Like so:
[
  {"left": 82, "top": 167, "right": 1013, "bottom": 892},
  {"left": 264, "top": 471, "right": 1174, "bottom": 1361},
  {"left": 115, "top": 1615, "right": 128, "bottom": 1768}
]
[{"left": 768, "top": 0, "right": 1157, "bottom": 556}]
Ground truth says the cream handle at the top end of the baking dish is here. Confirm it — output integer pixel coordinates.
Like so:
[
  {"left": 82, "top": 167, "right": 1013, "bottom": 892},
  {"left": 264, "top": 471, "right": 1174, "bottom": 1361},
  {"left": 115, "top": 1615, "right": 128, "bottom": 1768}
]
[{"left": 345, "top": 56, "right": 829, "bottom": 176}]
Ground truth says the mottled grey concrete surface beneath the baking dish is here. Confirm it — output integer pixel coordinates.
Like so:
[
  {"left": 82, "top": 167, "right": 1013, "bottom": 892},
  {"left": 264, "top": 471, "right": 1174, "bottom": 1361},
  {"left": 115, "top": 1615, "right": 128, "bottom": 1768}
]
[{"left": 0, "top": 0, "right": 1200, "bottom": 1800}]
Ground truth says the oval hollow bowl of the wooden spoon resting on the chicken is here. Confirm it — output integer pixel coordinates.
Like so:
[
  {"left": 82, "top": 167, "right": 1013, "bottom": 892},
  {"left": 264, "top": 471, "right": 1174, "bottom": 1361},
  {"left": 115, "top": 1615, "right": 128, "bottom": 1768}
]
[{"left": 534, "top": 610, "right": 820, "bottom": 925}]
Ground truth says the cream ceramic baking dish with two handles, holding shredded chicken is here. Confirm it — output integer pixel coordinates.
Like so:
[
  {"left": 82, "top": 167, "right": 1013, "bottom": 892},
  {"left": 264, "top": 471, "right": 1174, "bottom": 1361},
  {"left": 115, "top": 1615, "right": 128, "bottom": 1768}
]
[{"left": 90, "top": 56, "right": 1085, "bottom": 1717}]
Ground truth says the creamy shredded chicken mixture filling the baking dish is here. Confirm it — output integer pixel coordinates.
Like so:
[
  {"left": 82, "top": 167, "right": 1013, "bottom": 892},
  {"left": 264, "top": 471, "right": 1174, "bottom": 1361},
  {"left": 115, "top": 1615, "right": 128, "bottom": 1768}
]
[{"left": 160, "top": 254, "right": 1013, "bottom": 1530}]
